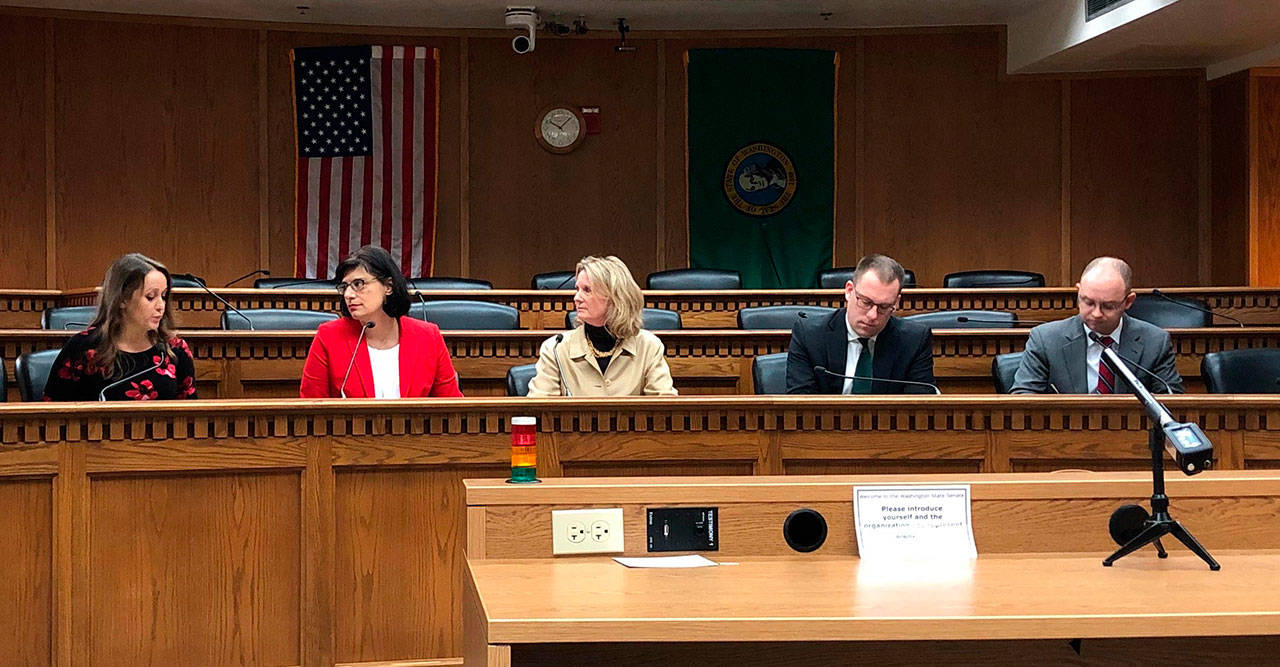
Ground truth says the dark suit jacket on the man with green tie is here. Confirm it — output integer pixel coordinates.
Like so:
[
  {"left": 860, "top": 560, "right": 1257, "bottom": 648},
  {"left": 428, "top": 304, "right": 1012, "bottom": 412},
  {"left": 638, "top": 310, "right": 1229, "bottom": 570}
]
[{"left": 787, "top": 309, "right": 937, "bottom": 394}]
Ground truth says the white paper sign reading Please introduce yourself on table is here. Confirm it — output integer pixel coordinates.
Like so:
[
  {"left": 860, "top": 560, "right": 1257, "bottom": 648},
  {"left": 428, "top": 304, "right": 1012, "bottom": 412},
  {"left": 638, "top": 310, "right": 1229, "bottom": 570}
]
[{"left": 854, "top": 484, "right": 978, "bottom": 559}]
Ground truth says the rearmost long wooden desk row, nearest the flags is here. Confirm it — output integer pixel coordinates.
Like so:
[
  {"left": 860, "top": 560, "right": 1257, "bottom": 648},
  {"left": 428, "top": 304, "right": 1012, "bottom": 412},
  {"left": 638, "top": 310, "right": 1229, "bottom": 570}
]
[{"left": 0, "top": 287, "right": 1280, "bottom": 329}]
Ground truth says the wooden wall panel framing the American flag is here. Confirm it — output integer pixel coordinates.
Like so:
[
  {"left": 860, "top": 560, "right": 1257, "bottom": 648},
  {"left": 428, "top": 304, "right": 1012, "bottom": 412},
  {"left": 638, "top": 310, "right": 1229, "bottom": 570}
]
[{"left": 259, "top": 29, "right": 462, "bottom": 277}]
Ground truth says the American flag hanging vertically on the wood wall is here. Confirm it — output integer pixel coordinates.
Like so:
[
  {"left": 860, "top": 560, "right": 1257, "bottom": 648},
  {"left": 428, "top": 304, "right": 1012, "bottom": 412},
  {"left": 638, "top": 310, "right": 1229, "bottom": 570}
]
[{"left": 293, "top": 46, "right": 439, "bottom": 278}]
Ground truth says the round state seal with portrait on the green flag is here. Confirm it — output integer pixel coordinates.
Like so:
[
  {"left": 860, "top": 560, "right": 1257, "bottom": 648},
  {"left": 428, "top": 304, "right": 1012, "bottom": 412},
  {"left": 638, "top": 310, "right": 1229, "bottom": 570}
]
[{"left": 722, "top": 142, "right": 796, "bottom": 216}]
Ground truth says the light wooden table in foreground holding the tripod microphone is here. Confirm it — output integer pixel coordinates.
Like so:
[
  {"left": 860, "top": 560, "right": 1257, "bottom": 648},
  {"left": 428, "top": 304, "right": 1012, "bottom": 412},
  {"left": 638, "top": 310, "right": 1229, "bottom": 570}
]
[{"left": 463, "top": 471, "right": 1280, "bottom": 664}]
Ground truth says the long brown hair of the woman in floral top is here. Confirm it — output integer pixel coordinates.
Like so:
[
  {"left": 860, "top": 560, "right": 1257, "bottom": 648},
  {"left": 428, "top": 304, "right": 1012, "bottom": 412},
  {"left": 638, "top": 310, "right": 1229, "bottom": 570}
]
[{"left": 90, "top": 252, "right": 174, "bottom": 375}]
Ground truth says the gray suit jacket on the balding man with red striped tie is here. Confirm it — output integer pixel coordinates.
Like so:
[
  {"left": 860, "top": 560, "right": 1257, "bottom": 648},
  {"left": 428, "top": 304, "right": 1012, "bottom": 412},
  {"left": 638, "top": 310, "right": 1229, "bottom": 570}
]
[{"left": 1011, "top": 315, "right": 1183, "bottom": 394}]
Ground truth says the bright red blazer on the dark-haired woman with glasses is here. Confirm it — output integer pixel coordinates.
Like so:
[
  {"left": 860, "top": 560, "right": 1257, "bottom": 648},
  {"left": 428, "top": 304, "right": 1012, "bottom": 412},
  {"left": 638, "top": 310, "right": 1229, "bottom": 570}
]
[{"left": 302, "top": 317, "right": 462, "bottom": 398}]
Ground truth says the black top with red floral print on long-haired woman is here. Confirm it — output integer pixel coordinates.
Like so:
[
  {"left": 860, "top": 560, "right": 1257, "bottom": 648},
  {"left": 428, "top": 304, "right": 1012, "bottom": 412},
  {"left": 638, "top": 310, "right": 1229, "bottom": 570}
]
[{"left": 45, "top": 329, "right": 196, "bottom": 401}]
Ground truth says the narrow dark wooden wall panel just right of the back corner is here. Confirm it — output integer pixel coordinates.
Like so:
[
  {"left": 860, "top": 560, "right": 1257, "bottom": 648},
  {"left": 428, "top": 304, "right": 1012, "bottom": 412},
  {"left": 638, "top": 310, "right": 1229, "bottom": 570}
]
[{"left": 1208, "top": 72, "right": 1249, "bottom": 285}]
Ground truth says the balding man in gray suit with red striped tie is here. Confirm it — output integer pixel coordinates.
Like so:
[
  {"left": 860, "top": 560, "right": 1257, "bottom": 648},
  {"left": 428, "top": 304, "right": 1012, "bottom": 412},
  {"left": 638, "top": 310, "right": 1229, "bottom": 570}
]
[{"left": 1011, "top": 257, "right": 1183, "bottom": 394}]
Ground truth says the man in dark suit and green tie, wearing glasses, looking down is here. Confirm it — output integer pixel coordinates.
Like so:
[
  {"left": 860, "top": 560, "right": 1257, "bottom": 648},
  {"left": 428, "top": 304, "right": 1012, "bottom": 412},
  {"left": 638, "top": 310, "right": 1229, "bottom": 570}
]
[{"left": 787, "top": 255, "right": 934, "bottom": 394}]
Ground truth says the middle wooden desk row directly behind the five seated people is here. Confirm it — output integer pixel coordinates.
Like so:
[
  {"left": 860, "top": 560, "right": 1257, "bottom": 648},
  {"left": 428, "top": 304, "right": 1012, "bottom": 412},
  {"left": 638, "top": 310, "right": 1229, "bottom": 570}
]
[{"left": 10, "top": 326, "right": 1280, "bottom": 401}]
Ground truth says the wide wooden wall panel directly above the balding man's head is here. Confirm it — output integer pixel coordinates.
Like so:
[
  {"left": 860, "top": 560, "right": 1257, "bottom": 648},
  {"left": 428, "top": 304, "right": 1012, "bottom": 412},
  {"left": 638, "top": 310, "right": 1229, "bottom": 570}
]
[{"left": 1070, "top": 73, "right": 1203, "bottom": 287}]
